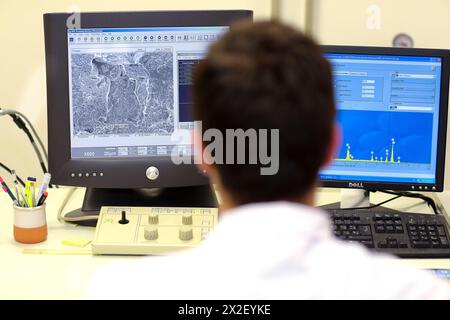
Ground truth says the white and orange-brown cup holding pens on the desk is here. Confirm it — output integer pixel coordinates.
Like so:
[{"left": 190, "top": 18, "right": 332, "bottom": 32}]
[{"left": 14, "top": 203, "right": 47, "bottom": 244}]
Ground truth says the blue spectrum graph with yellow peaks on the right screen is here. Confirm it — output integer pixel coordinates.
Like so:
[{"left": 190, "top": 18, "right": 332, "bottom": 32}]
[{"left": 335, "top": 110, "right": 433, "bottom": 165}]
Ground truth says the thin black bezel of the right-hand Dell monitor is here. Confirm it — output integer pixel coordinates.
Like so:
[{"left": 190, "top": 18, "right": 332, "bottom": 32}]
[{"left": 320, "top": 45, "right": 450, "bottom": 192}]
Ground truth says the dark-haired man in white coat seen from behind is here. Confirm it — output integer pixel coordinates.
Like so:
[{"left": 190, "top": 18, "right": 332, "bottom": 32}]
[{"left": 89, "top": 22, "right": 450, "bottom": 299}]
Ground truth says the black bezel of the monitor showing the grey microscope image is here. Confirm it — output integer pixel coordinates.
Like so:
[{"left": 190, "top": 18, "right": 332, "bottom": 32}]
[{"left": 43, "top": 10, "right": 253, "bottom": 189}]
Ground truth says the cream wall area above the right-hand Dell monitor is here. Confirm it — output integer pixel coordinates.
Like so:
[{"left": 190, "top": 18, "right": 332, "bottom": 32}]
[{"left": 280, "top": 0, "right": 450, "bottom": 190}]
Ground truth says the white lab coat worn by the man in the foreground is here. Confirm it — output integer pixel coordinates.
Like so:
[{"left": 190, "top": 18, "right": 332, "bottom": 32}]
[{"left": 87, "top": 202, "right": 450, "bottom": 299}]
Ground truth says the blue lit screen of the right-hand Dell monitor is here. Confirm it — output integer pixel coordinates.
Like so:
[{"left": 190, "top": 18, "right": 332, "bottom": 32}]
[{"left": 320, "top": 53, "right": 442, "bottom": 188}]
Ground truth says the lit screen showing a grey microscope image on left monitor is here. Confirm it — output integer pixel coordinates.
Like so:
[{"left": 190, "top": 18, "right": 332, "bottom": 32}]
[{"left": 67, "top": 26, "right": 229, "bottom": 159}]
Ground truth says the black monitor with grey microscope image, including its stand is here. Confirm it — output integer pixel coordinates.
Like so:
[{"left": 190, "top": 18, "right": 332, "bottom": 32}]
[{"left": 44, "top": 10, "right": 252, "bottom": 220}]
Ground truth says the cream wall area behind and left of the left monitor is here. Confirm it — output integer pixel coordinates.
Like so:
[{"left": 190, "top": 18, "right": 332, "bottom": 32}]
[{"left": 0, "top": 0, "right": 272, "bottom": 185}]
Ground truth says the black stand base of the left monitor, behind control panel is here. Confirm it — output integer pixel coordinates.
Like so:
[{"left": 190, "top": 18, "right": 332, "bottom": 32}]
[{"left": 65, "top": 185, "right": 218, "bottom": 227}]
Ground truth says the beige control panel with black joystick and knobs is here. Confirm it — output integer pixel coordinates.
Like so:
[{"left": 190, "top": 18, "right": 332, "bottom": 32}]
[{"left": 92, "top": 207, "right": 218, "bottom": 255}]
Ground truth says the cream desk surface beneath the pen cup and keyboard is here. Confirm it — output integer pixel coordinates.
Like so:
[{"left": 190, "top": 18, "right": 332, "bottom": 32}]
[{"left": 0, "top": 188, "right": 450, "bottom": 299}]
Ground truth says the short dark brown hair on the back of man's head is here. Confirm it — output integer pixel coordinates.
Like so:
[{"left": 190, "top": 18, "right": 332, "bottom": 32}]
[{"left": 193, "top": 22, "right": 335, "bottom": 204}]
